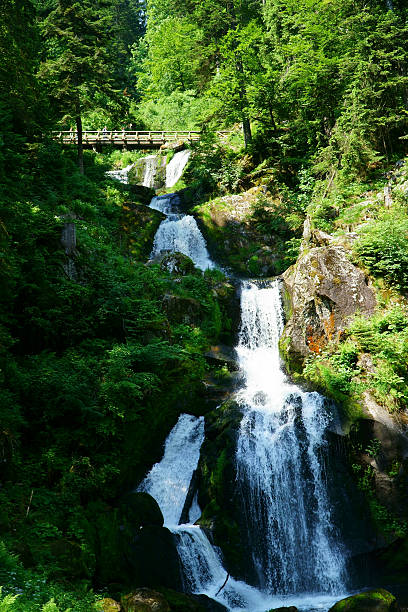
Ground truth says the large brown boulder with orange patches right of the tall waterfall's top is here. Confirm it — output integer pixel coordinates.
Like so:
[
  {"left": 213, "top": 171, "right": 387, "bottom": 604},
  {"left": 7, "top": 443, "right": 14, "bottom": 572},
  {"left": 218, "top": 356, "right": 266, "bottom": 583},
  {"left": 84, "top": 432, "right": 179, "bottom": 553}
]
[{"left": 281, "top": 246, "right": 376, "bottom": 370}]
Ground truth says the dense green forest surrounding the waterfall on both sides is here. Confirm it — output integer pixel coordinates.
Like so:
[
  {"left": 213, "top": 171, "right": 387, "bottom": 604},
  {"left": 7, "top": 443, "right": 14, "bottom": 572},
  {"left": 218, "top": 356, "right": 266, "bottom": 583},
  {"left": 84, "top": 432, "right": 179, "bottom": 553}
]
[{"left": 0, "top": 0, "right": 408, "bottom": 612}]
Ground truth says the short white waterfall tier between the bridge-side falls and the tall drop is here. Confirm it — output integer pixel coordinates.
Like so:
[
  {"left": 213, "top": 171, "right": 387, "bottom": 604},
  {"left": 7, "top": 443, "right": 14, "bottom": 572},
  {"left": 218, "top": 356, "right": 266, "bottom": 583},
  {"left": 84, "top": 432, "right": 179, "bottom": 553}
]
[{"left": 151, "top": 194, "right": 214, "bottom": 270}]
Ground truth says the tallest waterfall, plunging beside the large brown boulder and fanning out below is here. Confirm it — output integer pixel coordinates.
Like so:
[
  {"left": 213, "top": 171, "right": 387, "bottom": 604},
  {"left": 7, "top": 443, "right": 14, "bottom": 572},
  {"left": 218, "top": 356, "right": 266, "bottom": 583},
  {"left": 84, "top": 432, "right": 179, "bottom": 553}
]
[{"left": 236, "top": 282, "right": 345, "bottom": 594}]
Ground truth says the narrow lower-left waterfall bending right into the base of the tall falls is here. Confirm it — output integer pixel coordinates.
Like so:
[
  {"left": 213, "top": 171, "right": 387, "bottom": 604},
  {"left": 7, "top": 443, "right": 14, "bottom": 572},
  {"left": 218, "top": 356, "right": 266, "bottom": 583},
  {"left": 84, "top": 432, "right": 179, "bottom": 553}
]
[{"left": 137, "top": 414, "right": 274, "bottom": 612}]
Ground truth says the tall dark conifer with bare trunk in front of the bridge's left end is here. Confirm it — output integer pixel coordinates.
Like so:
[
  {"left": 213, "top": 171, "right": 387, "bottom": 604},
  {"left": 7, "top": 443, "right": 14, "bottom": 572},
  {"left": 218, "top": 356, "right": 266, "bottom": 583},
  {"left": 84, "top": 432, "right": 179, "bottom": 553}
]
[{"left": 40, "top": 0, "right": 115, "bottom": 174}]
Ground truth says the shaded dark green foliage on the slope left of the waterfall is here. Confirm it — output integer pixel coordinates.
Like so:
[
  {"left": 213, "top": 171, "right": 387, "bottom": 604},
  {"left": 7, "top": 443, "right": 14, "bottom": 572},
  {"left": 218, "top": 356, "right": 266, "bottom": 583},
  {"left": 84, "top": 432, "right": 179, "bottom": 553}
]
[{"left": 0, "top": 142, "right": 229, "bottom": 596}]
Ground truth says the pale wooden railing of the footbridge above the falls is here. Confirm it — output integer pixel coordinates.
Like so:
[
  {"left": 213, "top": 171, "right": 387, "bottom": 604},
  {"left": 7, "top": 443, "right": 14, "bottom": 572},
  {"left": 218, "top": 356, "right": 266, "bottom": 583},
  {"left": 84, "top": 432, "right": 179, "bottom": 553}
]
[{"left": 53, "top": 130, "right": 231, "bottom": 145}]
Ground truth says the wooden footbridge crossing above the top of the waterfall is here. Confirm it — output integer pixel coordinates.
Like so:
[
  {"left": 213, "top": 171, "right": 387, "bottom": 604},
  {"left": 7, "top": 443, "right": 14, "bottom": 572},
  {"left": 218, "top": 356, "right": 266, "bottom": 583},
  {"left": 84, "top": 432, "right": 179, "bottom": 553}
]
[{"left": 53, "top": 130, "right": 231, "bottom": 149}]
